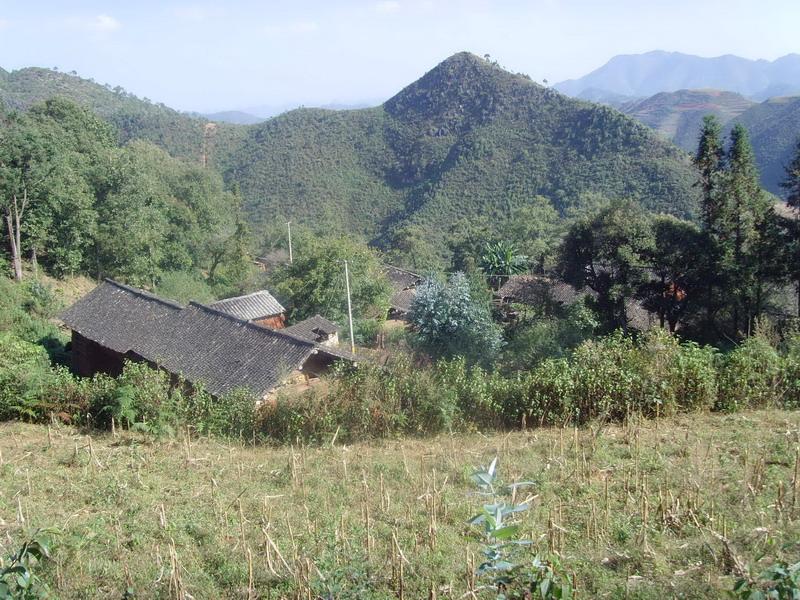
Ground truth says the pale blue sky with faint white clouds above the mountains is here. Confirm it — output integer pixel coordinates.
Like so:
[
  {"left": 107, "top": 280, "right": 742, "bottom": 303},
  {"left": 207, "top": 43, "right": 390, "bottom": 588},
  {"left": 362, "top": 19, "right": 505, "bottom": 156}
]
[{"left": 0, "top": 0, "right": 800, "bottom": 112}]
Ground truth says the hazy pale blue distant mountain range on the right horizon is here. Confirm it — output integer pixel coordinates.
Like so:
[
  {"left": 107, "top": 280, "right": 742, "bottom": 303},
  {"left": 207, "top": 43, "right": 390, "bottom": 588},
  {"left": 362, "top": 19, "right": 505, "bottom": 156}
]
[{"left": 555, "top": 50, "right": 800, "bottom": 100}]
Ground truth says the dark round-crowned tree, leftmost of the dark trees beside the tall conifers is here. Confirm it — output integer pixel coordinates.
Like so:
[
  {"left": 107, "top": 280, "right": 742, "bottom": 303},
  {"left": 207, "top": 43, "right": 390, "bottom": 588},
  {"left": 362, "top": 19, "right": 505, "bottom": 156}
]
[{"left": 558, "top": 200, "right": 653, "bottom": 330}]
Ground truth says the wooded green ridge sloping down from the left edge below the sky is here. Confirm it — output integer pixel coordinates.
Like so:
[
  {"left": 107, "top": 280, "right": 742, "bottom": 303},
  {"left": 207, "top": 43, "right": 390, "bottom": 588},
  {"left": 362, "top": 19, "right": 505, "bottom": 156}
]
[{"left": 0, "top": 67, "right": 247, "bottom": 162}]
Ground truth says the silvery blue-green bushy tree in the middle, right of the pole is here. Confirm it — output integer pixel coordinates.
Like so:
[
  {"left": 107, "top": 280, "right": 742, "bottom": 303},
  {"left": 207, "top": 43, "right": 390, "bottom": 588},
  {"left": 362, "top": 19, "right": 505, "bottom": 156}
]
[{"left": 409, "top": 272, "right": 502, "bottom": 364}]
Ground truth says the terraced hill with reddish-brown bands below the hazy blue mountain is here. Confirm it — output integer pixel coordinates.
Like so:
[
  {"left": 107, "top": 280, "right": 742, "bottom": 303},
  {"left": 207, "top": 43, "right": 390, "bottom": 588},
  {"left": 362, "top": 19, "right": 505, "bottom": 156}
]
[{"left": 620, "top": 90, "right": 756, "bottom": 152}]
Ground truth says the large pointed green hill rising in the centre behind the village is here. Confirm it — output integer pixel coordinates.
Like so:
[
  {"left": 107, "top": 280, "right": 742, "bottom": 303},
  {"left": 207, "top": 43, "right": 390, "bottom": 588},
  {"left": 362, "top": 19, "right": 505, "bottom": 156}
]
[{"left": 226, "top": 53, "right": 695, "bottom": 245}]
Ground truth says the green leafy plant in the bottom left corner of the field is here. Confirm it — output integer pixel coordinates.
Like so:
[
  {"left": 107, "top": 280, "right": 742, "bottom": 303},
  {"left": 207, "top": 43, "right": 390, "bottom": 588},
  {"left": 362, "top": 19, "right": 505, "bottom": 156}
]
[{"left": 0, "top": 529, "right": 51, "bottom": 600}]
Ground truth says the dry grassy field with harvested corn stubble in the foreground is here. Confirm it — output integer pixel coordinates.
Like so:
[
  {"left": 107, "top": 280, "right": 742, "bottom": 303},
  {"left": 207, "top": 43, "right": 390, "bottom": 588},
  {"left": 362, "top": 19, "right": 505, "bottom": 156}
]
[{"left": 0, "top": 411, "right": 800, "bottom": 599}]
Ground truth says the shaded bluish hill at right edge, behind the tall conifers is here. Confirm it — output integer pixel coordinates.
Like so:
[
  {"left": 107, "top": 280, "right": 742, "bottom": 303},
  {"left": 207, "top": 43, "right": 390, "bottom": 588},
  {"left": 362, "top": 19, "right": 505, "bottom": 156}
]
[{"left": 733, "top": 96, "right": 800, "bottom": 195}]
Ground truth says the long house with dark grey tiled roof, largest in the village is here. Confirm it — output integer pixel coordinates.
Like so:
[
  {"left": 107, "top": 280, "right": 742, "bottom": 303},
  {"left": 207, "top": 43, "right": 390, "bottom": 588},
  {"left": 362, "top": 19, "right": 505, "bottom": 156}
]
[{"left": 61, "top": 279, "right": 358, "bottom": 399}]
